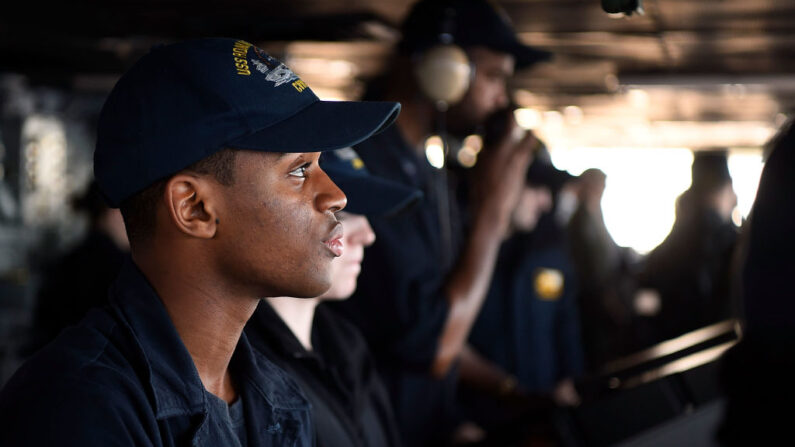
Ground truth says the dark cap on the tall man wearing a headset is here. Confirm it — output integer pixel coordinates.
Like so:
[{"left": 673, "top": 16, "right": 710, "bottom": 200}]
[{"left": 399, "top": 0, "right": 552, "bottom": 68}]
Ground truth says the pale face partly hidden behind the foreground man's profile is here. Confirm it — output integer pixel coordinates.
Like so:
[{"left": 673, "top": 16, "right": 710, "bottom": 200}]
[{"left": 321, "top": 211, "right": 375, "bottom": 300}]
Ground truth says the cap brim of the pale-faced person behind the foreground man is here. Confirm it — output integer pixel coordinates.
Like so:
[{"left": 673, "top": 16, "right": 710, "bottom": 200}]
[{"left": 324, "top": 168, "right": 422, "bottom": 216}]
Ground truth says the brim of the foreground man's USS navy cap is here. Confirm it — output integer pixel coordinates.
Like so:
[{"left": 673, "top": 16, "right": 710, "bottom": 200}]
[{"left": 228, "top": 101, "right": 400, "bottom": 152}]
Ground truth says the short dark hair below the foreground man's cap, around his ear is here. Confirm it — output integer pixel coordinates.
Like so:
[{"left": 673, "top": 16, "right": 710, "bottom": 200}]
[{"left": 119, "top": 149, "right": 237, "bottom": 245}]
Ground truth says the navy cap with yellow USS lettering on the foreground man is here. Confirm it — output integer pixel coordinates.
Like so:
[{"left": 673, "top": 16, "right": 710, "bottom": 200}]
[{"left": 94, "top": 39, "right": 400, "bottom": 207}]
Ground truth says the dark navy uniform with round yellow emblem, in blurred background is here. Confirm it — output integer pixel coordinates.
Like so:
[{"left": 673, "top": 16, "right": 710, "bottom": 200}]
[{"left": 469, "top": 162, "right": 583, "bottom": 393}]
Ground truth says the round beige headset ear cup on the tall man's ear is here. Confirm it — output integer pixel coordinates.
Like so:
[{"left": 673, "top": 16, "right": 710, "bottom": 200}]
[{"left": 414, "top": 44, "right": 474, "bottom": 105}]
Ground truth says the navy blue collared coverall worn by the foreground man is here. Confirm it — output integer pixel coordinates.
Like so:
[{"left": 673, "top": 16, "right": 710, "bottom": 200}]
[{"left": 0, "top": 260, "right": 314, "bottom": 447}]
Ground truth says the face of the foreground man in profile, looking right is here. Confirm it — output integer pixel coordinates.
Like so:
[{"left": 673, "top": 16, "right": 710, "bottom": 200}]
[{"left": 217, "top": 151, "right": 346, "bottom": 297}]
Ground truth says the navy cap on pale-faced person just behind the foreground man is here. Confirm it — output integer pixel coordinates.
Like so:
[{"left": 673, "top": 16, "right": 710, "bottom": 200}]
[{"left": 320, "top": 148, "right": 422, "bottom": 216}]
